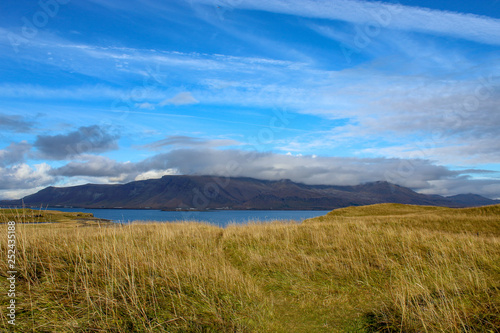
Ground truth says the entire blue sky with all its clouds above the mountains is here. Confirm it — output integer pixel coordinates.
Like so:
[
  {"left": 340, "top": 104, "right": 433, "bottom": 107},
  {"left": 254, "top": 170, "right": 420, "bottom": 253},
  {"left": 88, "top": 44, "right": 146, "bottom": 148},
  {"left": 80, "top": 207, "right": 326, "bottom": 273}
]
[{"left": 0, "top": 0, "right": 500, "bottom": 198}]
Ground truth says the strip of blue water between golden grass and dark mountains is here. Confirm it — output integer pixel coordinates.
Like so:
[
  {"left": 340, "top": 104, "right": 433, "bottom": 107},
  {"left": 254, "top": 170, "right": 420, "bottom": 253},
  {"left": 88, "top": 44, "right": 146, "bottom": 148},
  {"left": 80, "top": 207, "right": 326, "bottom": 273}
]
[{"left": 49, "top": 208, "right": 328, "bottom": 227}]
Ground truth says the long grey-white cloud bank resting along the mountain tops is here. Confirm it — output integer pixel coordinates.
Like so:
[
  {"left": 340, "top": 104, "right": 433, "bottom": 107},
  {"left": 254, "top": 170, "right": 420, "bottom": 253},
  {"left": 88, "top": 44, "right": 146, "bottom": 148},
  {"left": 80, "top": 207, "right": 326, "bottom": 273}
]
[{"left": 42, "top": 149, "right": 500, "bottom": 197}]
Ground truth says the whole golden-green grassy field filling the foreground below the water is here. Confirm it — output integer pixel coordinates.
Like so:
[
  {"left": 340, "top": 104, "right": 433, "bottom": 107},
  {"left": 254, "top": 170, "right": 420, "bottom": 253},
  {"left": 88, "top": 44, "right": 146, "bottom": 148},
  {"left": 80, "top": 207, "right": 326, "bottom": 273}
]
[{"left": 0, "top": 204, "right": 500, "bottom": 332}]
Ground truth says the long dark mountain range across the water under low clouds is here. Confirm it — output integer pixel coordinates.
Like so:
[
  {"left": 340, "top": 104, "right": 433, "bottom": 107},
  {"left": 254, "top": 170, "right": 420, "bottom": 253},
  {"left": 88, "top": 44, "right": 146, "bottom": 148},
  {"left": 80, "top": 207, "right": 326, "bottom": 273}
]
[{"left": 0, "top": 176, "right": 500, "bottom": 210}]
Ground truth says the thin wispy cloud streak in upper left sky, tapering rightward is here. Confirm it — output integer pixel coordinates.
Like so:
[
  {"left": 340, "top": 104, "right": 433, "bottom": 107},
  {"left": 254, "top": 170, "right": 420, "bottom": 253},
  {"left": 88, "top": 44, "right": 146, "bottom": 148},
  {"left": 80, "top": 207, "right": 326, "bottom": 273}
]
[{"left": 0, "top": 28, "right": 304, "bottom": 85}]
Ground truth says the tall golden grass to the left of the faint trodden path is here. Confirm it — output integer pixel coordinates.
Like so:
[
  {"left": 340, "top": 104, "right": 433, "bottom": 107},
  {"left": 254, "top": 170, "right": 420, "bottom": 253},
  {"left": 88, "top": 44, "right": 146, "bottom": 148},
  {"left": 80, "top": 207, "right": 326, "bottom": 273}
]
[{"left": 2, "top": 223, "right": 270, "bottom": 332}]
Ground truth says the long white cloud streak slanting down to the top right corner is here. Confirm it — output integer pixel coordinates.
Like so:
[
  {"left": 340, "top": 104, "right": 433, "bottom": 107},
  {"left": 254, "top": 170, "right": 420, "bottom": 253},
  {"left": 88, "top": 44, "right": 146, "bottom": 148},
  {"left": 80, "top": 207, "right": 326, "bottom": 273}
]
[{"left": 190, "top": 0, "right": 500, "bottom": 45}]
